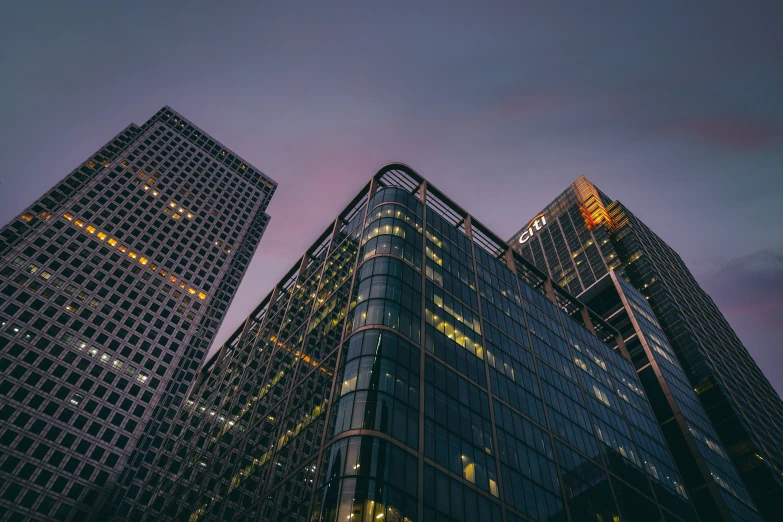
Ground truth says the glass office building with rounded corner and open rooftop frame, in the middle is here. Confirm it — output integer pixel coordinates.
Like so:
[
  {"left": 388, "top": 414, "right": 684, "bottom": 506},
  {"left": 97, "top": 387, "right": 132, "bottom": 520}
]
[{"left": 138, "top": 164, "right": 708, "bottom": 522}]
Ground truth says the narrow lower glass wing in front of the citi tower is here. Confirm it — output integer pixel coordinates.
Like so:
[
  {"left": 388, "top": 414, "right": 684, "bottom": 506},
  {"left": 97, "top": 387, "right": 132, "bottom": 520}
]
[{"left": 580, "top": 272, "right": 761, "bottom": 521}]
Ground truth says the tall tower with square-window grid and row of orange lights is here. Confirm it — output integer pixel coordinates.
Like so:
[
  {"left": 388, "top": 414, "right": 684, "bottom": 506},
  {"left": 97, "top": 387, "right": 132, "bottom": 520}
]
[{"left": 0, "top": 107, "right": 275, "bottom": 521}]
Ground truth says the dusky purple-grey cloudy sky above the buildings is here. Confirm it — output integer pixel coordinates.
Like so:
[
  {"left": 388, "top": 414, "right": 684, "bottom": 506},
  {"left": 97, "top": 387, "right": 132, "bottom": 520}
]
[{"left": 0, "top": 0, "right": 783, "bottom": 393}]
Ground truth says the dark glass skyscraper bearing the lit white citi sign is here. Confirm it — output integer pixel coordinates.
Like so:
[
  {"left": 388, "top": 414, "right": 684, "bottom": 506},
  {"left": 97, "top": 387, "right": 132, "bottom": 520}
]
[{"left": 509, "top": 177, "right": 783, "bottom": 520}]
